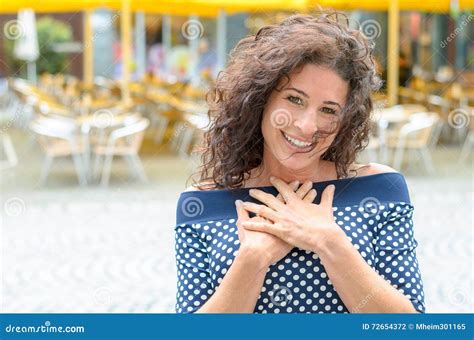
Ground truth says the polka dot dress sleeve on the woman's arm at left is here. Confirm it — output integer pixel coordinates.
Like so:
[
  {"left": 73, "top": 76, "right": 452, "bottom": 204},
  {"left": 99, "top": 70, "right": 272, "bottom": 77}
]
[{"left": 175, "top": 223, "right": 213, "bottom": 313}]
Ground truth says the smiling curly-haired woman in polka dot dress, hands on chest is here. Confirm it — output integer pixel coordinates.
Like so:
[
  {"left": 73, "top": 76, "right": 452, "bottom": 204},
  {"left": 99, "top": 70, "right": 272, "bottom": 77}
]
[{"left": 175, "top": 15, "right": 425, "bottom": 313}]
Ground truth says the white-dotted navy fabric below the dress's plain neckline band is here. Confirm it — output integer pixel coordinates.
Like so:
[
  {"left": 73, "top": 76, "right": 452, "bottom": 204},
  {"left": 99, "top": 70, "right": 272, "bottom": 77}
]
[{"left": 175, "top": 202, "right": 425, "bottom": 313}]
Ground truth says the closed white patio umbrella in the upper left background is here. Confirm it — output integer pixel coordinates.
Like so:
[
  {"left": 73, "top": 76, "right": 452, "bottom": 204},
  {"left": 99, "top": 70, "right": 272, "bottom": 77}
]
[{"left": 13, "top": 9, "right": 39, "bottom": 83}]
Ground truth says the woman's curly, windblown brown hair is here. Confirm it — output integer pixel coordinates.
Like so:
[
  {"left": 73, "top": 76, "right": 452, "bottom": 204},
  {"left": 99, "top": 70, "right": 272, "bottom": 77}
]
[{"left": 195, "top": 12, "right": 381, "bottom": 190}]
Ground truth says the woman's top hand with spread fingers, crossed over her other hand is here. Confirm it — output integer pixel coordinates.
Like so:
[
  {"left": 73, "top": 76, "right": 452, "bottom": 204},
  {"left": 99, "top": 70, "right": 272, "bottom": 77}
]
[{"left": 242, "top": 177, "right": 345, "bottom": 252}]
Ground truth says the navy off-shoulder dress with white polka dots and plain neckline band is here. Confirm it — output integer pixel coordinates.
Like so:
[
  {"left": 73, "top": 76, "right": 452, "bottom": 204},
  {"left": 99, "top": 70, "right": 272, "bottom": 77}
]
[{"left": 175, "top": 172, "right": 425, "bottom": 313}]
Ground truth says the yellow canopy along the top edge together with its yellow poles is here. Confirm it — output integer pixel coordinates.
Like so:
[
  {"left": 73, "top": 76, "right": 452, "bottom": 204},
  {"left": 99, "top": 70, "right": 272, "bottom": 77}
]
[{"left": 0, "top": 0, "right": 474, "bottom": 103}]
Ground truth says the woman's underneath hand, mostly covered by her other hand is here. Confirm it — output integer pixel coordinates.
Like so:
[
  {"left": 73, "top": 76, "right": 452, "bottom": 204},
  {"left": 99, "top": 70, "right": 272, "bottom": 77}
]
[{"left": 235, "top": 181, "right": 316, "bottom": 266}]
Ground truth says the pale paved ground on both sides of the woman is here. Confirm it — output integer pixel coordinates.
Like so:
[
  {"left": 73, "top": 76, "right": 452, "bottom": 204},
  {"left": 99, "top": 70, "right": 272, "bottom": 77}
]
[{"left": 0, "top": 129, "right": 474, "bottom": 313}]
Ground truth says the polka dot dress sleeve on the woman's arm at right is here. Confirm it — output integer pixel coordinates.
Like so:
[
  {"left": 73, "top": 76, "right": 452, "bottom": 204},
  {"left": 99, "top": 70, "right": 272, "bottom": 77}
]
[{"left": 375, "top": 202, "right": 426, "bottom": 313}]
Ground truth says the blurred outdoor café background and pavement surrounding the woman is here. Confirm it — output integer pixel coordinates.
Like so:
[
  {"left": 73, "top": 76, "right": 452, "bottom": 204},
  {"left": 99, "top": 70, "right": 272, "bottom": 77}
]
[{"left": 0, "top": 0, "right": 474, "bottom": 313}]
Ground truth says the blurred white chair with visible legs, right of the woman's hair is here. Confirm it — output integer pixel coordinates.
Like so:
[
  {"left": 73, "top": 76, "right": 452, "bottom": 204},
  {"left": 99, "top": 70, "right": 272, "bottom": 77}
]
[{"left": 387, "top": 112, "right": 440, "bottom": 174}]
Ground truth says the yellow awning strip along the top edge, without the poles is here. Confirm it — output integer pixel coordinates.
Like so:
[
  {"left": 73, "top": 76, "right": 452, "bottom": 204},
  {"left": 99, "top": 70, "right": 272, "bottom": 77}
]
[{"left": 0, "top": 0, "right": 474, "bottom": 16}]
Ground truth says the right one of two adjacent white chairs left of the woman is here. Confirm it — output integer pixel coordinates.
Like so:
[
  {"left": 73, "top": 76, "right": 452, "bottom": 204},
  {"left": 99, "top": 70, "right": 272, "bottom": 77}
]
[{"left": 93, "top": 117, "right": 150, "bottom": 187}]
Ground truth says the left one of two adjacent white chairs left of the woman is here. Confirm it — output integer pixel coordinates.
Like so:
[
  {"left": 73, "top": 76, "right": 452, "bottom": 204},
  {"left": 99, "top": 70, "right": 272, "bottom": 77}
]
[{"left": 30, "top": 116, "right": 87, "bottom": 186}]
